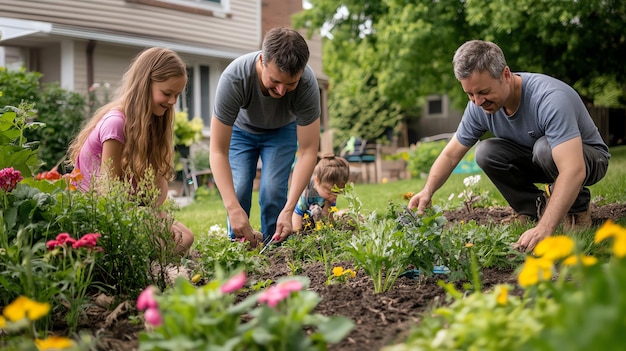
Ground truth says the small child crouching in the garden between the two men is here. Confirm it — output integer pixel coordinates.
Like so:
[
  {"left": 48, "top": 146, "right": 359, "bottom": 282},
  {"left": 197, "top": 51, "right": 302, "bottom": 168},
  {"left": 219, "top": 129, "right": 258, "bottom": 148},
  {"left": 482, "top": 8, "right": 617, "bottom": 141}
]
[{"left": 291, "top": 154, "right": 350, "bottom": 232}]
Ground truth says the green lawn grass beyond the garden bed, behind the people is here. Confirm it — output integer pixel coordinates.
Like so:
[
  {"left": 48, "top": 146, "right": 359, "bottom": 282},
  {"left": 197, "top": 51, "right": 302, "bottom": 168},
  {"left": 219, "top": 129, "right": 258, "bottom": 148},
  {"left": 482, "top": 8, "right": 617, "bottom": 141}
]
[{"left": 176, "top": 146, "right": 626, "bottom": 235}]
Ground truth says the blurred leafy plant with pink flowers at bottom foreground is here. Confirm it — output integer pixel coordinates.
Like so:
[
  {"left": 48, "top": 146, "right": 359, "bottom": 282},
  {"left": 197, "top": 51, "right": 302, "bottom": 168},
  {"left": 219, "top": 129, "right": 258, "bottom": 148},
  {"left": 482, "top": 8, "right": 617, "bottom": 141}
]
[{"left": 137, "top": 272, "right": 354, "bottom": 351}]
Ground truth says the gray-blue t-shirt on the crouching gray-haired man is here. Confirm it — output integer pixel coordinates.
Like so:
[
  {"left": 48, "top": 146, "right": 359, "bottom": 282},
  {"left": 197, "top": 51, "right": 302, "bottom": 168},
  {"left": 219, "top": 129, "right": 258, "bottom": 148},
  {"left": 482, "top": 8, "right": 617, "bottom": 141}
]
[{"left": 456, "top": 73, "right": 610, "bottom": 157}]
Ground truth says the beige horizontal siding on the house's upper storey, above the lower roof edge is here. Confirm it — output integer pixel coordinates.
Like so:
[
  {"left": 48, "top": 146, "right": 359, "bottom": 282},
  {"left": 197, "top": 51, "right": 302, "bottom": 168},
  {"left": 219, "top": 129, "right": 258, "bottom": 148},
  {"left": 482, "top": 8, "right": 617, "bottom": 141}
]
[{"left": 0, "top": 0, "right": 261, "bottom": 52}]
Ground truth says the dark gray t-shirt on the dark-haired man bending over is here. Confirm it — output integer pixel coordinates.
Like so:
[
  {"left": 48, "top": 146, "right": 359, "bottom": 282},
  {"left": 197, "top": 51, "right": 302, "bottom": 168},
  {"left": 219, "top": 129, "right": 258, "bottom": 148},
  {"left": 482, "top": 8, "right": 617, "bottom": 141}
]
[{"left": 214, "top": 51, "right": 321, "bottom": 134}]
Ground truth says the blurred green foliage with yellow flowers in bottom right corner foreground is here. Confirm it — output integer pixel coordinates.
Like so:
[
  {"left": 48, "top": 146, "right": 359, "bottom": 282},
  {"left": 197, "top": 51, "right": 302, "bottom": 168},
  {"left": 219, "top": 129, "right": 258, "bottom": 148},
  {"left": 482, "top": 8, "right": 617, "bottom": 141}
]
[{"left": 383, "top": 220, "right": 626, "bottom": 351}]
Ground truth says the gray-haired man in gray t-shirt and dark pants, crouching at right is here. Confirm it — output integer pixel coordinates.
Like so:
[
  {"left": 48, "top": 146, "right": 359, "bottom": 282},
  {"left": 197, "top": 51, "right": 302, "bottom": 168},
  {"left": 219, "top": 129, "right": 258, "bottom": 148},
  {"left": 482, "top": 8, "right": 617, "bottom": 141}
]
[{"left": 409, "top": 40, "right": 611, "bottom": 252}]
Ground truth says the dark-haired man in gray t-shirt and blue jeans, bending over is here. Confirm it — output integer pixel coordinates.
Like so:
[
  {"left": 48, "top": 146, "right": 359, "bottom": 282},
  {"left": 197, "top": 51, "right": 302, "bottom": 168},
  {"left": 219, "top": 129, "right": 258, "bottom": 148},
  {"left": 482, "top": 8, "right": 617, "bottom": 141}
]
[{"left": 210, "top": 28, "right": 321, "bottom": 246}]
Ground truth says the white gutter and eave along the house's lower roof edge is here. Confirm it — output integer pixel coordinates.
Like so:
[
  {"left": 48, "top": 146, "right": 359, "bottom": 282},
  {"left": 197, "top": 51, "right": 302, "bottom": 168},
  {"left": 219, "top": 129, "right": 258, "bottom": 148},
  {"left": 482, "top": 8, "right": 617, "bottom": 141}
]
[{"left": 0, "top": 17, "right": 243, "bottom": 59}]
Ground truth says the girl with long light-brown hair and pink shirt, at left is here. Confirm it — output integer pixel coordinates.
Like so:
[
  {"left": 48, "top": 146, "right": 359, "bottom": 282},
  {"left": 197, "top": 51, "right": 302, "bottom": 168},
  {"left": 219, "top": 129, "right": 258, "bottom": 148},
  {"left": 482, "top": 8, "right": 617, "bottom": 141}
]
[{"left": 68, "top": 47, "right": 194, "bottom": 254}]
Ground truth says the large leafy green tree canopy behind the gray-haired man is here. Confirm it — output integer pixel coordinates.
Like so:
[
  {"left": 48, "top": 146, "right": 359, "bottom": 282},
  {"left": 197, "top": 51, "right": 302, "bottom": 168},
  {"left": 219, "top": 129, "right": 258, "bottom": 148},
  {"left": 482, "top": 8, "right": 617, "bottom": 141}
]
[{"left": 293, "top": 0, "right": 626, "bottom": 146}]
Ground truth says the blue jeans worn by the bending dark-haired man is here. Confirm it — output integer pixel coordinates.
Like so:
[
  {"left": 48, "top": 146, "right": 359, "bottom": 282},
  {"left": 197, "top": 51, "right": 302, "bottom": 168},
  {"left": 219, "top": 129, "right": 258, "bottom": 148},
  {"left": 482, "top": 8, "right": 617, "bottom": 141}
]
[{"left": 227, "top": 122, "right": 298, "bottom": 240}]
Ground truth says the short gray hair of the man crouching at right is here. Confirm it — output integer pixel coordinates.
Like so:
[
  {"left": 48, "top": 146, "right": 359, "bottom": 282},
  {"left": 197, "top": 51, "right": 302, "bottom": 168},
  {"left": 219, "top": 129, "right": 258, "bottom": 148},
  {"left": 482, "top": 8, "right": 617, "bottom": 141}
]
[{"left": 452, "top": 40, "right": 506, "bottom": 81}]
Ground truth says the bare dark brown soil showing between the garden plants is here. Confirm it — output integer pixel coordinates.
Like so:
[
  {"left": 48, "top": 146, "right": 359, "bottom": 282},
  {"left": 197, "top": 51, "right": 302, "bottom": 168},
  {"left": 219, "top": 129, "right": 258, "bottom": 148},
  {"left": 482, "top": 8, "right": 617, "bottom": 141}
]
[{"left": 75, "top": 204, "right": 626, "bottom": 351}]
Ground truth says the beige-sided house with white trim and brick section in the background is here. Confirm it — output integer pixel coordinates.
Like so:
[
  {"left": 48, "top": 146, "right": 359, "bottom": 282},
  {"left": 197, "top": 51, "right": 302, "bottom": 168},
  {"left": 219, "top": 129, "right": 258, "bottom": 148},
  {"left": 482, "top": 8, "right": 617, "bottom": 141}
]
[{"left": 0, "top": 0, "right": 328, "bottom": 148}]
